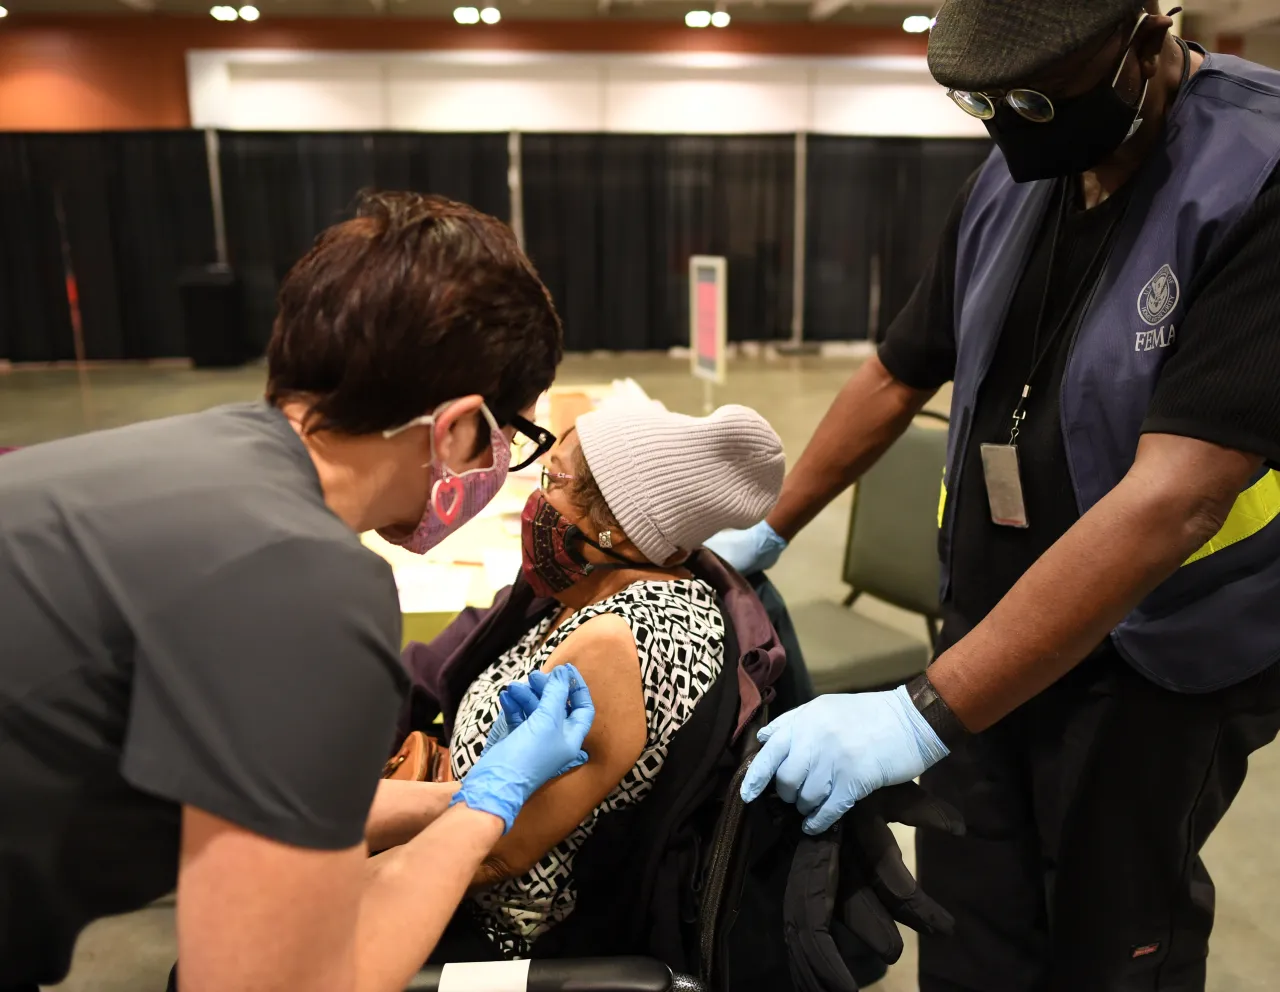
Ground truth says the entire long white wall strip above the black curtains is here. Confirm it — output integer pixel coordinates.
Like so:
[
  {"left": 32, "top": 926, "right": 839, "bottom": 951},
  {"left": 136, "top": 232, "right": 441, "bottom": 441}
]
[{"left": 187, "top": 51, "right": 986, "bottom": 137}]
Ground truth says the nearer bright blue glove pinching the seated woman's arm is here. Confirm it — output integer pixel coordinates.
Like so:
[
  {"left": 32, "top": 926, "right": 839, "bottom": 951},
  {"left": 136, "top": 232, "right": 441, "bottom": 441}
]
[{"left": 449, "top": 664, "right": 595, "bottom": 832}]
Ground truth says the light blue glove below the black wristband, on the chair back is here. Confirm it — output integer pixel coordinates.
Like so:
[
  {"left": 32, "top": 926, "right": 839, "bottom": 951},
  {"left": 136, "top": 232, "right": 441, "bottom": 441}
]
[{"left": 742, "top": 686, "right": 948, "bottom": 833}]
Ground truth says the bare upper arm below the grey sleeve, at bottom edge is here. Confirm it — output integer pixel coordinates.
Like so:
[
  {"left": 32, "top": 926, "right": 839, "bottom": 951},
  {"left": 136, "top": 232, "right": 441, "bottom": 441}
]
[{"left": 178, "top": 806, "right": 366, "bottom": 992}]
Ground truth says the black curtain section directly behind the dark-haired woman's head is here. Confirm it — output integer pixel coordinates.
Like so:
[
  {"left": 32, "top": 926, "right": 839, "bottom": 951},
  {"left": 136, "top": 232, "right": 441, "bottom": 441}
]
[{"left": 219, "top": 132, "right": 511, "bottom": 351}]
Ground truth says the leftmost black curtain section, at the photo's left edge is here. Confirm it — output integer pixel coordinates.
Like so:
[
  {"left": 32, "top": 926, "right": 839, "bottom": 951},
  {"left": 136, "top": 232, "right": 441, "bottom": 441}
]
[{"left": 0, "top": 131, "right": 215, "bottom": 362}]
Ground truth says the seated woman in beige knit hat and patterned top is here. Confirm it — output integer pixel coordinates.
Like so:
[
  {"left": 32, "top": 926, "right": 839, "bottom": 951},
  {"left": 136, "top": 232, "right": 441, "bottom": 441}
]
[{"left": 440, "top": 406, "right": 785, "bottom": 959}]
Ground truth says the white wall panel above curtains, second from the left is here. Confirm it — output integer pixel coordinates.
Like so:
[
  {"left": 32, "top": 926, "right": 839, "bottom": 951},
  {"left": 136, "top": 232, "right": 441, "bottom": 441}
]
[{"left": 387, "top": 61, "right": 604, "bottom": 131}]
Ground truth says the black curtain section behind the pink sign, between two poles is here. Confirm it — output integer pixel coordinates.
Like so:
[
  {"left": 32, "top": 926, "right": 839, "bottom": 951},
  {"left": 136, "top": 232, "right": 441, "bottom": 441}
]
[{"left": 521, "top": 134, "right": 795, "bottom": 351}]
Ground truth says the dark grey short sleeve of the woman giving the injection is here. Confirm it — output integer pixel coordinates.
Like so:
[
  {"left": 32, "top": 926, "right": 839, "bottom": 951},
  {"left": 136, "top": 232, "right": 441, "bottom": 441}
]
[{"left": 122, "top": 538, "right": 406, "bottom": 850}]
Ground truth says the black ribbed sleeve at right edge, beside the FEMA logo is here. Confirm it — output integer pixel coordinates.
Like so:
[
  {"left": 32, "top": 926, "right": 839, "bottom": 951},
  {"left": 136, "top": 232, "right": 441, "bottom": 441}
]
[{"left": 1142, "top": 166, "right": 1280, "bottom": 466}]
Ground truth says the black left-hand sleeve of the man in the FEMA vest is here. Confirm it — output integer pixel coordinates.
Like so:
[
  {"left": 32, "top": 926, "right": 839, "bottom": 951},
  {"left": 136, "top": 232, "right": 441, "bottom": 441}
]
[{"left": 878, "top": 168, "right": 982, "bottom": 389}]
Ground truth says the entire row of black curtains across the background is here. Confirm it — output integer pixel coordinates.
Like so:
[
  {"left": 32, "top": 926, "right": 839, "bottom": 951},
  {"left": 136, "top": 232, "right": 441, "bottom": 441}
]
[{"left": 0, "top": 131, "right": 989, "bottom": 362}]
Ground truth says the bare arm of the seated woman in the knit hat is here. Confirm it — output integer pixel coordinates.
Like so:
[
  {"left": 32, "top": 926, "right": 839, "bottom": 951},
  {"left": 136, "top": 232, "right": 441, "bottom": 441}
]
[{"left": 476, "top": 613, "right": 649, "bottom": 883}]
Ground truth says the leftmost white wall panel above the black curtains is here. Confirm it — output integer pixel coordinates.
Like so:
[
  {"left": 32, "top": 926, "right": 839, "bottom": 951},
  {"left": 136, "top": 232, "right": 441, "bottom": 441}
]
[{"left": 230, "top": 59, "right": 387, "bottom": 131}]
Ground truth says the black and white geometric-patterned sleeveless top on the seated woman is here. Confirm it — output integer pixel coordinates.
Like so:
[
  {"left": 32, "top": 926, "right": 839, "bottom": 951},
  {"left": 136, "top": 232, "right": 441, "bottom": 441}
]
[{"left": 449, "top": 579, "right": 724, "bottom": 957}]
